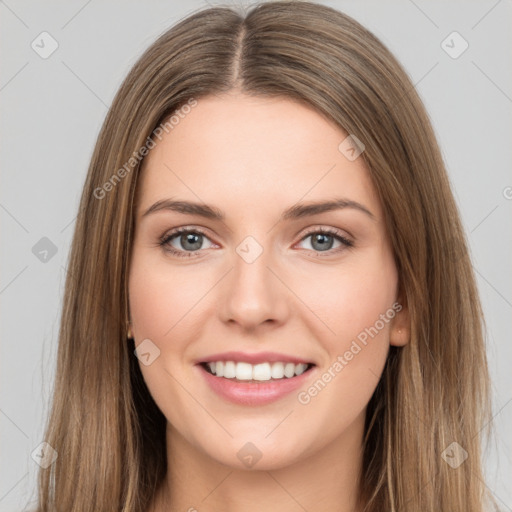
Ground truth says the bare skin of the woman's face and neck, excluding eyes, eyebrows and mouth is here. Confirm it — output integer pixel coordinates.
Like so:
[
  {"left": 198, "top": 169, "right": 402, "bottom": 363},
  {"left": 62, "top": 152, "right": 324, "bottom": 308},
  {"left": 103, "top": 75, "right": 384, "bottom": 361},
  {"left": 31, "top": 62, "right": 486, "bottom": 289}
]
[{"left": 129, "top": 92, "right": 409, "bottom": 512}]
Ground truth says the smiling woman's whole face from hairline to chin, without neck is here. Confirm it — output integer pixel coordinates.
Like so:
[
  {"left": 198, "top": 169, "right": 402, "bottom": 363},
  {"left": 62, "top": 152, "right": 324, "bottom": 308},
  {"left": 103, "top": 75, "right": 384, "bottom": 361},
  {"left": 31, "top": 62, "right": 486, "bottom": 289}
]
[{"left": 129, "top": 94, "right": 407, "bottom": 469}]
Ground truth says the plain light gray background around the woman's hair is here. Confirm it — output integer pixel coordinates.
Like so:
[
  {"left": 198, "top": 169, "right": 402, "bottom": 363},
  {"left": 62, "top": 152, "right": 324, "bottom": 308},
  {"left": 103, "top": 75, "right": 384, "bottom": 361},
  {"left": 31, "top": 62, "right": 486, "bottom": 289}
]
[{"left": 0, "top": 0, "right": 512, "bottom": 512}]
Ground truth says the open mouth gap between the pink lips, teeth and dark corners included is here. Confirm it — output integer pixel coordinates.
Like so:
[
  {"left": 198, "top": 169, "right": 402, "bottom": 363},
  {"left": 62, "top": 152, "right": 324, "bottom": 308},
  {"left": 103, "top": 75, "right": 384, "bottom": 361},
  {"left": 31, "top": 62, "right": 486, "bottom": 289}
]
[{"left": 199, "top": 361, "right": 315, "bottom": 384}]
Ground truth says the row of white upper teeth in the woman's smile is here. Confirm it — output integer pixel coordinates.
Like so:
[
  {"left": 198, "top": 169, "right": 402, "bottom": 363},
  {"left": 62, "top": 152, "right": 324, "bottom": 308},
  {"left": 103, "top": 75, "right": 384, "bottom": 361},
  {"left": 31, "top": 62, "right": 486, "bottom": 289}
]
[{"left": 208, "top": 361, "right": 308, "bottom": 381}]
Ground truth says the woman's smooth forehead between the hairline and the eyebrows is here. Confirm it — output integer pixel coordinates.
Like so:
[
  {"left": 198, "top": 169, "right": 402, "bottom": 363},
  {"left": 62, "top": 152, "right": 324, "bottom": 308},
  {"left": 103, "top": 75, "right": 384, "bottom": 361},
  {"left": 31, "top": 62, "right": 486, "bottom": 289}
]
[{"left": 134, "top": 93, "right": 380, "bottom": 220}]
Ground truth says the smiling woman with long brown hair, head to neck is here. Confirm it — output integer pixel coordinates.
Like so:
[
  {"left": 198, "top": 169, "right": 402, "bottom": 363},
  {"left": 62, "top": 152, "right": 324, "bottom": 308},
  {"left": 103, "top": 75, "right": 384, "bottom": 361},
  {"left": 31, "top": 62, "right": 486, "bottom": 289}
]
[{"left": 33, "top": 2, "right": 496, "bottom": 512}]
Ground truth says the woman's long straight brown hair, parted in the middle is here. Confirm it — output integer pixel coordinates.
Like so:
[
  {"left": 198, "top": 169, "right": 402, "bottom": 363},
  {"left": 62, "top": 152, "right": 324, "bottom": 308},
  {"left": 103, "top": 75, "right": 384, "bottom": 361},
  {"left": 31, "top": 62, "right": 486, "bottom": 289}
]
[{"left": 33, "top": 1, "right": 496, "bottom": 512}]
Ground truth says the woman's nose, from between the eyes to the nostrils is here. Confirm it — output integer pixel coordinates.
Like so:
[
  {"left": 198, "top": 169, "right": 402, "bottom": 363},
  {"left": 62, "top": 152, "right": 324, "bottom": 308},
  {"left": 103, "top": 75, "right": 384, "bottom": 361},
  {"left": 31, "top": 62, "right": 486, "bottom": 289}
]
[{"left": 220, "top": 241, "right": 290, "bottom": 330}]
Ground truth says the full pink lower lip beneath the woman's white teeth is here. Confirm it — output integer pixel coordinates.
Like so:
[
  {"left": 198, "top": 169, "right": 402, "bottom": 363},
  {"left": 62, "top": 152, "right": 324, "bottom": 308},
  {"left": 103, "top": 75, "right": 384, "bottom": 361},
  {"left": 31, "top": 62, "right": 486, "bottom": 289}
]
[{"left": 196, "top": 364, "right": 315, "bottom": 405}]
